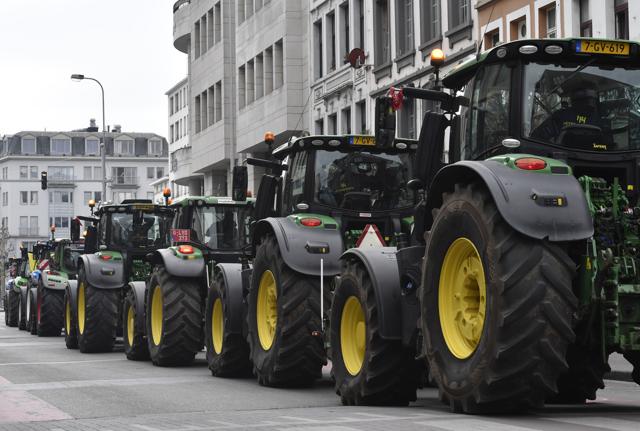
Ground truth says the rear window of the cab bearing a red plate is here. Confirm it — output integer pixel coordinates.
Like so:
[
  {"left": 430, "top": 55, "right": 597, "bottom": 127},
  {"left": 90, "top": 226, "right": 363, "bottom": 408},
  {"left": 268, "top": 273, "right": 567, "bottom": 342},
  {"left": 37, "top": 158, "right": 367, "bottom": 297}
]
[{"left": 192, "top": 205, "right": 251, "bottom": 250}]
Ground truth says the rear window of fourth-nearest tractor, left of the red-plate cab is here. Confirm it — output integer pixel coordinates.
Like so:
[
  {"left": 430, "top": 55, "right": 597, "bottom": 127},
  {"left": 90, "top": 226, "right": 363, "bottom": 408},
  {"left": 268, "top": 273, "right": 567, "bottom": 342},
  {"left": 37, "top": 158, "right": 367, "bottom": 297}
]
[{"left": 111, "top": 211, "right": 171, "bottom": 248}]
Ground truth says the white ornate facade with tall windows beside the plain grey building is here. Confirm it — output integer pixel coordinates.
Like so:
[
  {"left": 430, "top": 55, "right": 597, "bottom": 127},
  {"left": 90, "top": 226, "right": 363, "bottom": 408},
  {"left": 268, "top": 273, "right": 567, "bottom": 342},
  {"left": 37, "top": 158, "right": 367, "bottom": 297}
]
[{"left": 309, "top": 0, "right": 477, "bottom": 145}]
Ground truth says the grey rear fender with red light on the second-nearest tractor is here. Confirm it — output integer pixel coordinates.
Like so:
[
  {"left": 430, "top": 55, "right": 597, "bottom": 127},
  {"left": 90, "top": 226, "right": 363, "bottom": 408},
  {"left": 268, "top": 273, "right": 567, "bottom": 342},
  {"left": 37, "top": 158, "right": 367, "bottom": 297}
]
[{"left": 252, "top": 217, "right": 344, "bottom": 277}]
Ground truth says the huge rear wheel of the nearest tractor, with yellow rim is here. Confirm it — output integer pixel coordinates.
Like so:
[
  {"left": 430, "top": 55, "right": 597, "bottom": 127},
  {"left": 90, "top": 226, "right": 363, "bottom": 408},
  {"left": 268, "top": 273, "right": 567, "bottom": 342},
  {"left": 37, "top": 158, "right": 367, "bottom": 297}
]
[{"left": 418, "top": 184, "right": 577, "bottom": 413}]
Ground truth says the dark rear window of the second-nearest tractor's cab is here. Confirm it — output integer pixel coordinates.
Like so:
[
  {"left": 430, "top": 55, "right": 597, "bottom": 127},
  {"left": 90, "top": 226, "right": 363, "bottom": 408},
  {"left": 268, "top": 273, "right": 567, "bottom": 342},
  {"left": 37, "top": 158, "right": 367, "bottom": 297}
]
[{"left": 314, "top": 150, "right": 414, "bottom": 211}]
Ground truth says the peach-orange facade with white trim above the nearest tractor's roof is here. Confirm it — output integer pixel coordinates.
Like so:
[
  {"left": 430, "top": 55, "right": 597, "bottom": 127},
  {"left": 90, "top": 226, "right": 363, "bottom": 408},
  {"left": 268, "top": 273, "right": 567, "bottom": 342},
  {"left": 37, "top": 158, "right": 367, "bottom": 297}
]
[{"left": 477, "top": 0, "right": 640, "bottom": 49}]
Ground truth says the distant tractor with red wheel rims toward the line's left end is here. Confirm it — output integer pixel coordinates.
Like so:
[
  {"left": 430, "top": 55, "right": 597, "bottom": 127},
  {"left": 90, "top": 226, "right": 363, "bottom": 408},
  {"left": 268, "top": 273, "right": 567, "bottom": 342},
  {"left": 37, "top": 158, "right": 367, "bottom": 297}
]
[{"left": 27, "top": 233, "right": 84, "bottom": 337}]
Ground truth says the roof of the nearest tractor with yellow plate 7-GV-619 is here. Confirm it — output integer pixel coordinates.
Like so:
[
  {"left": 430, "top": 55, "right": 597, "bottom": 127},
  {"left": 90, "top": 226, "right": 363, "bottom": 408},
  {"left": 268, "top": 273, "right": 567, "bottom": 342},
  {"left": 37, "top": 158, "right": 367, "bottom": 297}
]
[{"left": 442, "top": 38, "right": 640, "bottom": 89}]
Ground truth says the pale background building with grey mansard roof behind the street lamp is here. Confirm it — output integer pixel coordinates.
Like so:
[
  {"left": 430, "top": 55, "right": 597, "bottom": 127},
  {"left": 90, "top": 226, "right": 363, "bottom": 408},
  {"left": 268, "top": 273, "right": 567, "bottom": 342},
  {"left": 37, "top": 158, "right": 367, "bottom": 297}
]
[{"left": 0, "top": 127, "right": 168, "bottom": 255}]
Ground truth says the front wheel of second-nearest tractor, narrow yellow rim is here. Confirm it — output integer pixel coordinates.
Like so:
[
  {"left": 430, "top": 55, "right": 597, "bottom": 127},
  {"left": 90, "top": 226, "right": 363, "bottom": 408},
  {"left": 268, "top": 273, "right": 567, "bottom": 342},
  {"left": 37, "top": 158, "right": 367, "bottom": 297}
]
[{"left": 204, "top": 272, "right": 251, "bottom": 377}]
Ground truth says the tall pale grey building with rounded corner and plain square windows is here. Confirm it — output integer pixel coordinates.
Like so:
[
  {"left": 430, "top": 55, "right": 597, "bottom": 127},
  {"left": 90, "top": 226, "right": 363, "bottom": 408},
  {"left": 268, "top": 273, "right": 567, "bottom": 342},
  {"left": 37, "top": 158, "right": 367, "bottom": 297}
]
[{"left": 172, "top": 0, "right": 309, "bottom": 195}]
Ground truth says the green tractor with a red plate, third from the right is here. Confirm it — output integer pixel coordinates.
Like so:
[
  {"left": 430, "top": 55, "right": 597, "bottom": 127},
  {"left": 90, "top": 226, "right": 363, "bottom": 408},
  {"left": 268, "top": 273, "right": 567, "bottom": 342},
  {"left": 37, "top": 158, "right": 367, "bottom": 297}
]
[{"left": 138, "top": 197, "right": 254, "bottom": 367}]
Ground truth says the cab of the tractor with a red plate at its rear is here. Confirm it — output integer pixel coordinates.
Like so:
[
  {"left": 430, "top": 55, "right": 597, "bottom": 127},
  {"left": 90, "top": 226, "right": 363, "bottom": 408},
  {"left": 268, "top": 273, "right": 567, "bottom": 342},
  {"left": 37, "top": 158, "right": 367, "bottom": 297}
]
[{"left": 171, "top": 196, "right": 255, "bottom": 263}]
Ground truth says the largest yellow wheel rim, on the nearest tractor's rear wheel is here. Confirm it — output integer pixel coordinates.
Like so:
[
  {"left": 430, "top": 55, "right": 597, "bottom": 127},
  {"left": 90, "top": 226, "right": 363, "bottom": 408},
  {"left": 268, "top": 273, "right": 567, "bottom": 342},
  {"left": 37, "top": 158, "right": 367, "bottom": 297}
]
[{"left": 438, "top": 238, "right": 487, "bottom": 359}]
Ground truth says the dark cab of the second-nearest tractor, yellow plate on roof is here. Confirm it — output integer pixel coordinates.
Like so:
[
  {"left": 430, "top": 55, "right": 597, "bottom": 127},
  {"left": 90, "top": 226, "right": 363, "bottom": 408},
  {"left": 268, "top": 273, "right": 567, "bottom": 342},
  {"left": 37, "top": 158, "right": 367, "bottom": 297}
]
[{"left": 248, "top": 135, "right": 417, "bottom": 250}]
